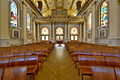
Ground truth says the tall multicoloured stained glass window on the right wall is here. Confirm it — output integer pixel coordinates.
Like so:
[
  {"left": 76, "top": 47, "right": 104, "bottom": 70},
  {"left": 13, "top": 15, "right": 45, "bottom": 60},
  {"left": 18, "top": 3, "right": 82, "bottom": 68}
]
[{"left": 101, "top": 0, "right": 109, "bottom": 27}]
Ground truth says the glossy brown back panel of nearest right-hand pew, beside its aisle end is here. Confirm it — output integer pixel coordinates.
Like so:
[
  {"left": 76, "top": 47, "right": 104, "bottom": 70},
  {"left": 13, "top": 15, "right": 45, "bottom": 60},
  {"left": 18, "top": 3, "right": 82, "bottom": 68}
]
[{"left": 92, "top": 66, "right": 116, "bottom": 80}]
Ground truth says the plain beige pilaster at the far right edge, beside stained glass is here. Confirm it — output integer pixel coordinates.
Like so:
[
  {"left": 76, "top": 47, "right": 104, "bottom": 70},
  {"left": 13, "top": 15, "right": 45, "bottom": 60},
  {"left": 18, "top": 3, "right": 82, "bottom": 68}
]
[{"left": 108, "top": 0, "right": 120, "bottom": 46}]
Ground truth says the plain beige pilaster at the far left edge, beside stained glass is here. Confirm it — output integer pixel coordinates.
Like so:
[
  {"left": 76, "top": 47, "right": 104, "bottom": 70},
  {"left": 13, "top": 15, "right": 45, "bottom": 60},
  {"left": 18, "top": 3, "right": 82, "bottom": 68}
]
[{"left": 0, "top": 0, "right": 11, "bottom": 46}]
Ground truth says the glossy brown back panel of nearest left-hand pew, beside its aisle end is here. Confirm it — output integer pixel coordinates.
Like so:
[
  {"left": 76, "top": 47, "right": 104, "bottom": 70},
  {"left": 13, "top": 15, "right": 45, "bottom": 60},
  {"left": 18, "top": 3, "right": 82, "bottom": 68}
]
[{"left": 3, "top": 67, "right": 27, "bottom": 80}]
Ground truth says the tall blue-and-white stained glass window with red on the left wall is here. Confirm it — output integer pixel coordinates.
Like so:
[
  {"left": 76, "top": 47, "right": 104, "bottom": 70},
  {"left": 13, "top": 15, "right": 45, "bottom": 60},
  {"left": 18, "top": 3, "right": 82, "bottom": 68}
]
[{"left": 10, "top": 0, "right": 18, "bottom": 27}]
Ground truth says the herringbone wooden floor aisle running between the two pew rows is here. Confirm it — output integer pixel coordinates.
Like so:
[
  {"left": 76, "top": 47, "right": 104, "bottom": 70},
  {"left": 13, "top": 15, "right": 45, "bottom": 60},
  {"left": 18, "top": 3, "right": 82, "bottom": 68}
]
[{"left": 35, "top": 45, "right": 80, "bottom": 80}]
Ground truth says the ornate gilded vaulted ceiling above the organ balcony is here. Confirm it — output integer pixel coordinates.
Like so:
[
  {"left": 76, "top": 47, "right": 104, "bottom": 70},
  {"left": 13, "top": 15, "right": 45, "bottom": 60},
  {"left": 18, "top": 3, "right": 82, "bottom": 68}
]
[{"left": 32, "top": 0, "right": 86, "bottom": 15}]
